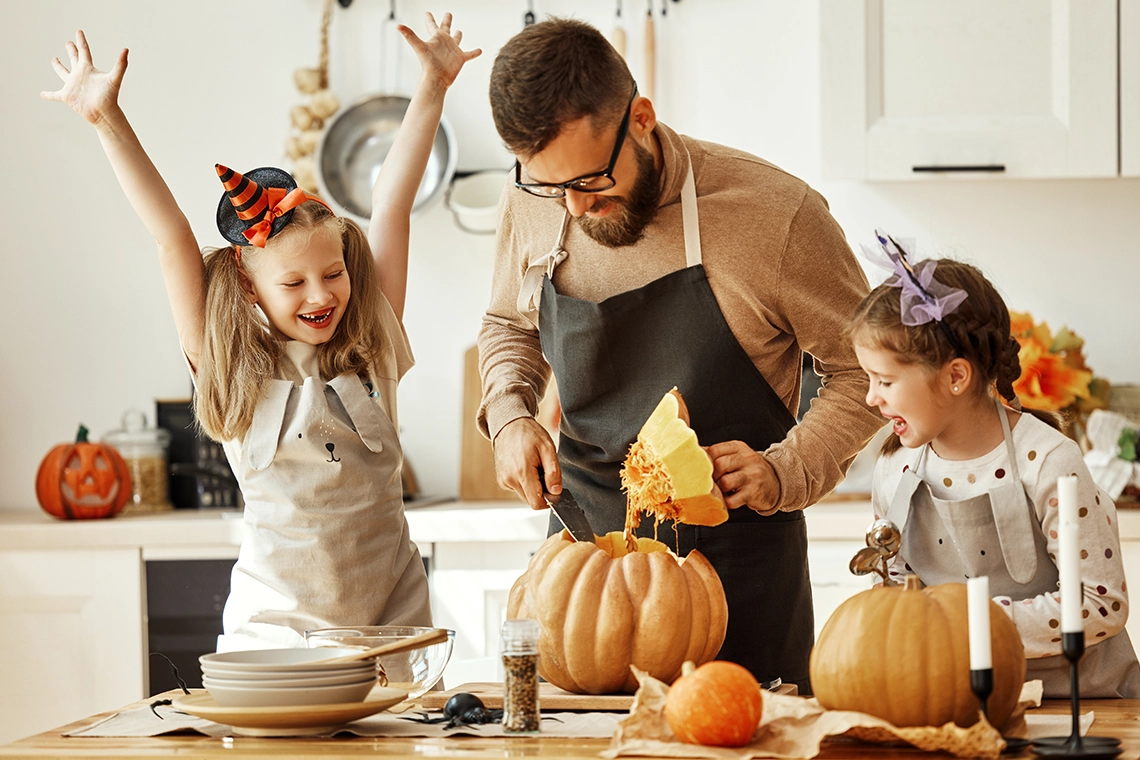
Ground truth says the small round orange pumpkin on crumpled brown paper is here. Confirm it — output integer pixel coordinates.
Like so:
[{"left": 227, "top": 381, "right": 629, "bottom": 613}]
[{"left": 665, "top": 660, "right": 764, "bottom": 746}]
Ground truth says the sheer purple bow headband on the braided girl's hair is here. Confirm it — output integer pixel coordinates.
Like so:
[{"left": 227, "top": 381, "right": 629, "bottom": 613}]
[{"left": 860, "top": 229, "right": 966, "bottom": 327}]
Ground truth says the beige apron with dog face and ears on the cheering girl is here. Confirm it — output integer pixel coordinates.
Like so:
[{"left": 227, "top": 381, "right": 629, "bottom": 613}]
[{"left": 218, "top": 341, "right": 431, "bottom": 651}]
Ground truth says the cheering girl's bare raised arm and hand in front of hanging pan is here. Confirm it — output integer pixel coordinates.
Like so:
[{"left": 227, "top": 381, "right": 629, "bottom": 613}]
[{"left": 368, "top": 14, "right": 482, "bottom": 319}]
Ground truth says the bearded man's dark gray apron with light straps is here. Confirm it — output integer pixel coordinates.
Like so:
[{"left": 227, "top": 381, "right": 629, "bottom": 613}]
[{"left": 519, "top": 150, "right": 815, "bottom": 694}]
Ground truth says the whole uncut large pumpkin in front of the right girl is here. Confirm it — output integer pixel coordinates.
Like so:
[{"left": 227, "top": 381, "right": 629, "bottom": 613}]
[{"left": 811, "top": 575, "right": 1025, "bottom": 729}]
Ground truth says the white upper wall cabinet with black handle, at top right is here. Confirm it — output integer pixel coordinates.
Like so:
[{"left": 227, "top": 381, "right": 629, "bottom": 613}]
[{"left": 821, "top": 0, "right": 1117, "bottom": 180}]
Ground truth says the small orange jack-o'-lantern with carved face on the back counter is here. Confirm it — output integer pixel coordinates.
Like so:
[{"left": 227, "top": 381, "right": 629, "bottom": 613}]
[{"left": 35, "top": 425, "right": 131, "bottom": 520}]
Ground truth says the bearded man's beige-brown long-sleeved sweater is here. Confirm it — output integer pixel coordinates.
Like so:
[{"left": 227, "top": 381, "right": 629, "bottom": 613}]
[{"left": 479, "top": 123, "right": 884, "bottom": 510}]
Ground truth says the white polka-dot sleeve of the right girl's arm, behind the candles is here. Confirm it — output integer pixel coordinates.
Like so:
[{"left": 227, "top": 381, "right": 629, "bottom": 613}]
[{"left": 994, "top": 443, "right": 1129, "bottom": 659}]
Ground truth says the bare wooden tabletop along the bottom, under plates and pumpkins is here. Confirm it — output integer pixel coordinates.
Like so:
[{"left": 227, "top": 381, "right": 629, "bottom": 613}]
[{"left": 0, "top": 697, "right": 1140, "bottom": 760}]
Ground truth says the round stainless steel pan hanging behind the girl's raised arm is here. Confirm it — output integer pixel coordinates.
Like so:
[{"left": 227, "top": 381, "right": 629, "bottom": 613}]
[{"left": 317, "top": 95, "right": 458, "bottom": 227}]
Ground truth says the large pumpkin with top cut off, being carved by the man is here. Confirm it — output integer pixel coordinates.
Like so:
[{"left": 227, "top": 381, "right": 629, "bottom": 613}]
[{"left": 507, "top": 531, "right": 728, "bottom": 694}]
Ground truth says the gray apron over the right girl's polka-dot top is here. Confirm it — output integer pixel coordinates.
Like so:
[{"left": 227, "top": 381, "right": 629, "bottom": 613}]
[{"left": 886, "top": 403, "right": 1140, "bottom": 697}]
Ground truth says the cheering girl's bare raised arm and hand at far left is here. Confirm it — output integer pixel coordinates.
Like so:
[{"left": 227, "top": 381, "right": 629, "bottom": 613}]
[{"left": 40, "top": 31, "right": 205, "bottom": 366}]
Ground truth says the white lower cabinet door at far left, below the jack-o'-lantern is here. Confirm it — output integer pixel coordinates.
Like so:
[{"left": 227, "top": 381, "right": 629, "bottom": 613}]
[{"left": 0, "top": 548, "right": 146, "bottom": 744}]
